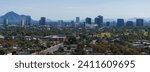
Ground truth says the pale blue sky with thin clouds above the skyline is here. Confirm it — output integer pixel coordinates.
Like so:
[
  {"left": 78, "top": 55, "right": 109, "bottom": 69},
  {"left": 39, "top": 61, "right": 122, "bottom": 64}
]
[{"left": 0, "top": 0, "right": 150, "bottom": 20}]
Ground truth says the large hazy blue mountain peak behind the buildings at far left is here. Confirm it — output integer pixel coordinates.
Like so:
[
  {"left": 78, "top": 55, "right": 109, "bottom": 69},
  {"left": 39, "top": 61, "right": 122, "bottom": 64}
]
[{"left": 0, "top": 11, "right": 32, "bottom": 24}]
